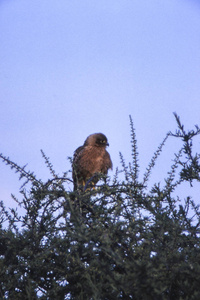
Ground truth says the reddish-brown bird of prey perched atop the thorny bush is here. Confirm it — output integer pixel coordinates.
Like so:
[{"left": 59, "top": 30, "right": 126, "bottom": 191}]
[{"left": 72, "top": 133, "right": 112, "bottom": 190}]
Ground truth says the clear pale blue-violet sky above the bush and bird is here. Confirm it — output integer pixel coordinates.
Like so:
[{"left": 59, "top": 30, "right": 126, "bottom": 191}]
[{"left": 0, "top": 0, "right": 200, "bottom": 213}]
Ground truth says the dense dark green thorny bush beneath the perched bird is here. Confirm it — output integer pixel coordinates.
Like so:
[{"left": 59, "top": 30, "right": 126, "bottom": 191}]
[{"left": 0, "top": 114, "right": 200, "bottom": 300}]
